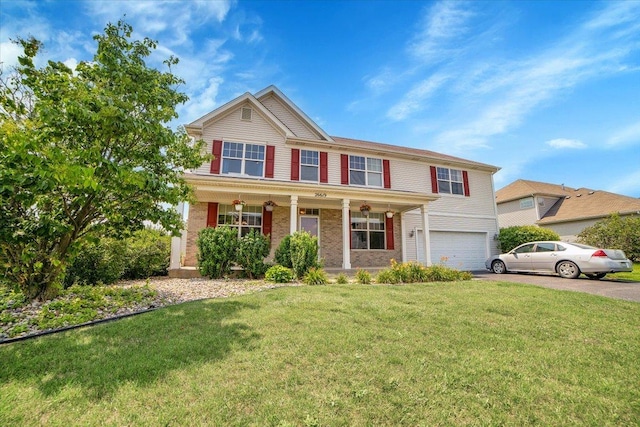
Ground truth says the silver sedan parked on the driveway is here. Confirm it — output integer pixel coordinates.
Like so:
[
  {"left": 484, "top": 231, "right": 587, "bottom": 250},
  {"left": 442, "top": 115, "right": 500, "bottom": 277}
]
[{"left": 484, "top": 242, "right": 633, "bottom": 279}]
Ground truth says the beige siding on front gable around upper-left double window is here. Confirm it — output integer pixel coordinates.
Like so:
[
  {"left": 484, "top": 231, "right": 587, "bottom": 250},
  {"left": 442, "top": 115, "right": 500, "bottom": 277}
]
[{"left": 196, "top": 104, "right": 291, "bottom": 179}]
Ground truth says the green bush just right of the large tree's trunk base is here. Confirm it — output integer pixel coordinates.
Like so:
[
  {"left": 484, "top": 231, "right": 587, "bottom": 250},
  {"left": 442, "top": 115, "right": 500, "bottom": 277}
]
[{"left": 64, "top": 238, "right": 127, "bottom": 288}]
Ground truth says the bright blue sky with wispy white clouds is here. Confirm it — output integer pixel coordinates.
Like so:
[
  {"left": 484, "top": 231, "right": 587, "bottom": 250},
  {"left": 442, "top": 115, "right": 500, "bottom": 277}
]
[{"left": 0, "top": 0, "right": 640, "bottom": 197}]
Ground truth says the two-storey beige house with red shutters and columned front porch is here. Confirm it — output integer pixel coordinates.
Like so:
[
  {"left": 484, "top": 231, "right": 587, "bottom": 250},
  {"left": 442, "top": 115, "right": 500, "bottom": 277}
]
[{"left": 170, "top": 86, "right": 498, "bottom": 276}]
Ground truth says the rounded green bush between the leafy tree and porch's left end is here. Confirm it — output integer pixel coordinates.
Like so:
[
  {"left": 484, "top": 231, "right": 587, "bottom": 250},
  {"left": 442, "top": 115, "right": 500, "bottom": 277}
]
[{"left": 123, "top": 228, "right": 171, "bottom": 279}]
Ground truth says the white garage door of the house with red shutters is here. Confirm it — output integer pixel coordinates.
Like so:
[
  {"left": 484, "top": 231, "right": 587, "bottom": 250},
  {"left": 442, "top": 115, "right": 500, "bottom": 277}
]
[{"left": 416, "top": 230, "right": 488, "bottom": 270}]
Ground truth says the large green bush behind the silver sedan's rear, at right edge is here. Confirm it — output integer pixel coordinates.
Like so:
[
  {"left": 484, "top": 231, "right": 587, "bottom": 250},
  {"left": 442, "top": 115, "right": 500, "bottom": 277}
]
[{"left": 578, "top": 214, "right": 640, "bottom": 262}]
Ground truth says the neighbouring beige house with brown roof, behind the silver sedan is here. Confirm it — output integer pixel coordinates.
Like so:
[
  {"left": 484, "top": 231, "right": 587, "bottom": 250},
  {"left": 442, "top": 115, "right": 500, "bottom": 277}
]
[{"left": 496, "top": 179, "right": 640, "bottom": 242}]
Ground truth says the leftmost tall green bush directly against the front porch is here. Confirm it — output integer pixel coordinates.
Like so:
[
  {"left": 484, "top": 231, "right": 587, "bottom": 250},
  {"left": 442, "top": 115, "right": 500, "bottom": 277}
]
[{"left": 196, "top": 226, "right": 239, "bottom": 279}]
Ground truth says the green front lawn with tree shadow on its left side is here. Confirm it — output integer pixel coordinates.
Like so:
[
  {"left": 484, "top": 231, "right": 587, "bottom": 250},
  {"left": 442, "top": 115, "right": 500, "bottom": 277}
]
[{"left": 0, "top": 281, "right": 640, "bottom": 426}]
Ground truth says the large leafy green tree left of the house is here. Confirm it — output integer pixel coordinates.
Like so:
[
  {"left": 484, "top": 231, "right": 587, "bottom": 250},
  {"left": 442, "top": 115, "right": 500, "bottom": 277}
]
[{"left": 0, "top": 21, "right": 206, "bottom": 299}]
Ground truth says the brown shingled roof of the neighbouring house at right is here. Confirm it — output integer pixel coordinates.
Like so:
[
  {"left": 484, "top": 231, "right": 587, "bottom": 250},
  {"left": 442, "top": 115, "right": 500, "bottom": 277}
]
[{"left": 496, "top": 179, "right": 640, "bottom": 225}]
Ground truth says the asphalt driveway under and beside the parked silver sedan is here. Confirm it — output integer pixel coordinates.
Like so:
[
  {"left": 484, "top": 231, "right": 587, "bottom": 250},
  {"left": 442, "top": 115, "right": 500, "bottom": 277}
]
[{"left": 473, "top": 271, "right": 640, "bottom": 302}]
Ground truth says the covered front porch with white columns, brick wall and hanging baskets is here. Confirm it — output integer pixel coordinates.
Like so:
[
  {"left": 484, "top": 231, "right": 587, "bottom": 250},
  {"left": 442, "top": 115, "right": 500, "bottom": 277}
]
[{"left": 170, "top": 176, "right": 437, "bottom": 274}]
